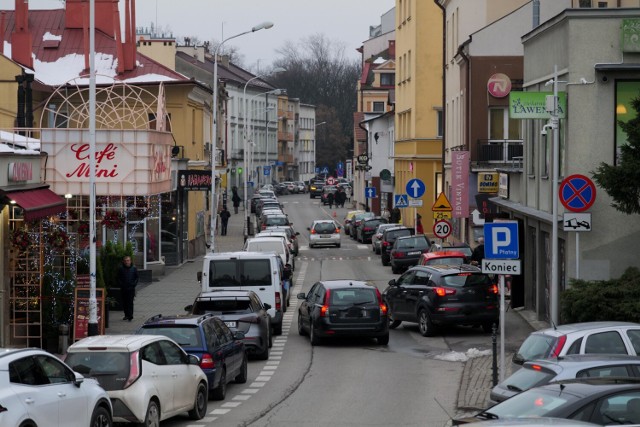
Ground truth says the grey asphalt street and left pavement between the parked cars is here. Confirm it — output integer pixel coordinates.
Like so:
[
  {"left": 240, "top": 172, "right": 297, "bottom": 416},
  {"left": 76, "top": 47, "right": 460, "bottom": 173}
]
[{"left": 108, "top": 194, "right": 531, "bottom": 427}]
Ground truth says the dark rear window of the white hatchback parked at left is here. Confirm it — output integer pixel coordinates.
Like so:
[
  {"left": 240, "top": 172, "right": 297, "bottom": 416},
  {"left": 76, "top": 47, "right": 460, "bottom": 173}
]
[{"left": 65, "top": 351, "right": 130, "bottom": 391}]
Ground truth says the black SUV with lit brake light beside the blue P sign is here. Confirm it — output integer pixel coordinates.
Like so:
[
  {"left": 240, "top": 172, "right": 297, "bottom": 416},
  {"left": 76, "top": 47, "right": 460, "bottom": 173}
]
[{"left": 382, "top": 264, "right": 499, "bottom": 337}]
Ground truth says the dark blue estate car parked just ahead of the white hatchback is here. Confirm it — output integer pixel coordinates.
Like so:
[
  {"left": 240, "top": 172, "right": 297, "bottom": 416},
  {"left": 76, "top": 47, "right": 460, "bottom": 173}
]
[{"left": 136, "top": 314, "right": 248, "bottom": 400}]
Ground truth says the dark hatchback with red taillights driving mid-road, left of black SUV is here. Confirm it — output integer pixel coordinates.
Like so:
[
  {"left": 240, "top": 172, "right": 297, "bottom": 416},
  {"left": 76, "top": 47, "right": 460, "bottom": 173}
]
[{"left": 298, "top": 280, "right": 389, "bottom": 345}]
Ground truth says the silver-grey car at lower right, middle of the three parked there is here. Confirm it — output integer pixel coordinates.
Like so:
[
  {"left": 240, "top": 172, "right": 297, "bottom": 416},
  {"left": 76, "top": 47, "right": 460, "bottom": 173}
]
[{"left": 489, "top": 354, "right": 640, "bottom": 406}]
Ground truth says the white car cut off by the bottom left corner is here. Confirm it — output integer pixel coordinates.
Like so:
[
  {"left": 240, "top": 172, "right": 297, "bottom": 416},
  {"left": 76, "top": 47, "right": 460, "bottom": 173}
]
[{"left": 0, "top": 348, "right": 113, "bottom": 427}]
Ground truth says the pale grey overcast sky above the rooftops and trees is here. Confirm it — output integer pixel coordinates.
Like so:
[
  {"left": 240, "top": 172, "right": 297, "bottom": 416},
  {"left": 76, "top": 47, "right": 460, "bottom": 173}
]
[{"left": 7, "top": 0, "right": 395, "bottom": 67}]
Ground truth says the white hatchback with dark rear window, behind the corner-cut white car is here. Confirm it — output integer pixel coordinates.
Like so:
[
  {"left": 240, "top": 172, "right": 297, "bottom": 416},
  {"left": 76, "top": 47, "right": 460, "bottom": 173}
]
[{"left": 64, "top": 335, "right": 208, "bottom": 426}]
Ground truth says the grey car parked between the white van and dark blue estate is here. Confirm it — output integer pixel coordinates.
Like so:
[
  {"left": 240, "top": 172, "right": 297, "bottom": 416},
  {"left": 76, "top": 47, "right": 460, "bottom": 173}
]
[{"left": 184, "top": 291, "right": 272, "bottom": 360}]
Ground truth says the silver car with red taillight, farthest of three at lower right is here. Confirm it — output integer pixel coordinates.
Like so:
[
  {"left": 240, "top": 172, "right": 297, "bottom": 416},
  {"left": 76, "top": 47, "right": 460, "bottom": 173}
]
[{"left": 512, "top": 322, "right": 640, "bottom": 365}]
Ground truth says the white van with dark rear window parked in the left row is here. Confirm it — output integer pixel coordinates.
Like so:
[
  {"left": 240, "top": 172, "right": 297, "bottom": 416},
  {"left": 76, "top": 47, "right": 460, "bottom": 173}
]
[{"left": 198, "top": 251, "right": 286, "bottom": 335}]
